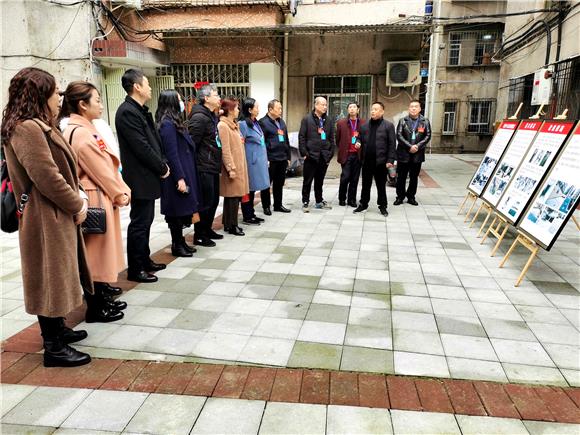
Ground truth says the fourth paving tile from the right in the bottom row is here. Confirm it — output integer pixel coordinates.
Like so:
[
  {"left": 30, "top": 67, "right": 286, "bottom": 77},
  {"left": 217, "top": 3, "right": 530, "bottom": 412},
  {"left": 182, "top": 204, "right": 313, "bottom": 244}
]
[{"left": 326, "top": 405, "right": 393, "bottom": 435}]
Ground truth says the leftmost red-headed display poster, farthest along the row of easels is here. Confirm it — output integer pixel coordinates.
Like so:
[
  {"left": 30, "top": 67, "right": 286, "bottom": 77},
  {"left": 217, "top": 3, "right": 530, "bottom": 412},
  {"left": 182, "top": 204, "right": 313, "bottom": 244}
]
[{"left": 467, "top": 121, "right": 519, "bottom": 196}]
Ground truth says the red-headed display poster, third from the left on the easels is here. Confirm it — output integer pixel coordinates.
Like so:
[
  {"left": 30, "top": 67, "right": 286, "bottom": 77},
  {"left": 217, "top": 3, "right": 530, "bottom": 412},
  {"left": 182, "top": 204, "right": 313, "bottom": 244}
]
[{"left": 496, "top": 121, "right": 574, "bottom": 225}]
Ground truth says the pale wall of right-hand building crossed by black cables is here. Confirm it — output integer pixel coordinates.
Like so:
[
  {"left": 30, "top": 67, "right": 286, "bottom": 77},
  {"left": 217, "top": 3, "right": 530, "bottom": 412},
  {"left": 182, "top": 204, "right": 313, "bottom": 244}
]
[{"left": 498, "top": 0, "right": 580, "bottom": 116}]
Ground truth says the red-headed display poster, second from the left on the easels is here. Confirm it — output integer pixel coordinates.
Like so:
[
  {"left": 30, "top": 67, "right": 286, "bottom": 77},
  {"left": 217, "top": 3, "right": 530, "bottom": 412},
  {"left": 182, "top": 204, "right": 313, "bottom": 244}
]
[{"left": 481, "top": 120, "right": 543, "bottom": 207}]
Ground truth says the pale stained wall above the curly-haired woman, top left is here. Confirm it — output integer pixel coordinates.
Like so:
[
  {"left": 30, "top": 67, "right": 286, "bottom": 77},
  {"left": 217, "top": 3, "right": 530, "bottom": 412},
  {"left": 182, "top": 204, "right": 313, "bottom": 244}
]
[{"left": 0, "top": 0, "right": 95, "bottom": 108}]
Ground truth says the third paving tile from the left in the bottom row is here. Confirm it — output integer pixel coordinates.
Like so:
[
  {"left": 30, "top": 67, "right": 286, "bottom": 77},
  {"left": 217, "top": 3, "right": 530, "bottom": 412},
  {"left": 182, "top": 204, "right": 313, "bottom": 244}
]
[{"left": 62, "top": 390, "right": 148, "bottom": 432}]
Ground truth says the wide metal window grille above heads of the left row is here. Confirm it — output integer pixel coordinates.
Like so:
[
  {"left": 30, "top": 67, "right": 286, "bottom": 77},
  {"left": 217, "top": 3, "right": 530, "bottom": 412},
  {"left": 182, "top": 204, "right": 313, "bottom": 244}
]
[{"left": 157, "top": 64, "right": 250, "bottom": 100}]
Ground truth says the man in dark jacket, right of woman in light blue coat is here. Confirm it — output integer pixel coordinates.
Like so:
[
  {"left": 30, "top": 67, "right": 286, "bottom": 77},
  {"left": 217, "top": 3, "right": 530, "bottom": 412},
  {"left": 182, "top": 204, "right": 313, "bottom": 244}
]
[{"left": 260, "top": 100, "right": 290, "bottom": 216}]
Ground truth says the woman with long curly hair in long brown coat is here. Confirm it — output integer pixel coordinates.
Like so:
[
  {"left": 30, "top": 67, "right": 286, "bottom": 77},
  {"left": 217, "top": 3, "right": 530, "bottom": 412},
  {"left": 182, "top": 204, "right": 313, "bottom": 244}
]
[{"left": 1, "top": 68, "right": 93, "bottom": 367}]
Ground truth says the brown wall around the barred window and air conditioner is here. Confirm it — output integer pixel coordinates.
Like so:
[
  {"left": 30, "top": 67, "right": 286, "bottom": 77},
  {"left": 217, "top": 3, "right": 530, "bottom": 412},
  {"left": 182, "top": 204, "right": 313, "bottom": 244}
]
[{"left": 285, "top": 33, "right": 421, "bottom": 130}]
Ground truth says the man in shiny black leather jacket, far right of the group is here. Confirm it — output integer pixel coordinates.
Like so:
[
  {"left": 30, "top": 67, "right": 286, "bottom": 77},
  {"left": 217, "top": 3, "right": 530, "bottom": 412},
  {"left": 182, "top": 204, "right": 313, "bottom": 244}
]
[{"left": 394, "top": 100, "right": 431, "bottom": 205}]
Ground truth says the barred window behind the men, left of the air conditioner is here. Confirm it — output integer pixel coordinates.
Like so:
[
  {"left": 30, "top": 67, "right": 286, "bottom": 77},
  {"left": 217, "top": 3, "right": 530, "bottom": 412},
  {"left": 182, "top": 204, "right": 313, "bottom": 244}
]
[{"left": 313, "top": 76, "right": 372, "bottom": 122}]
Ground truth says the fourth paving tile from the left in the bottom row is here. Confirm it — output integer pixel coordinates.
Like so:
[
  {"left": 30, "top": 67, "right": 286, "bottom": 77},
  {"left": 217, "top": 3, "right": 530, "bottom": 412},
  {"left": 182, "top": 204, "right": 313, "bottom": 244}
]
[{"left": 125, "top": 394, "right": 206, "bottom": 435}]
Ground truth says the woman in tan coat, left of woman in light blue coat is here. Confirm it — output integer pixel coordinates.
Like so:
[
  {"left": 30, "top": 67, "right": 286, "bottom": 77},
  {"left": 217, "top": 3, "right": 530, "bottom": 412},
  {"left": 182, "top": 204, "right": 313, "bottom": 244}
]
[{"left": 218, "top": 98, "right": 250, "bottom": 236}]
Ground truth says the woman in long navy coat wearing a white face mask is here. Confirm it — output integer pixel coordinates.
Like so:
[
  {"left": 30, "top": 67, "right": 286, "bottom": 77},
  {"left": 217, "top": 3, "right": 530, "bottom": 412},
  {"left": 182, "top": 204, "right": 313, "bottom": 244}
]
[{"left": 155, "top": 89, "right": 199, "bottom": 257}]
